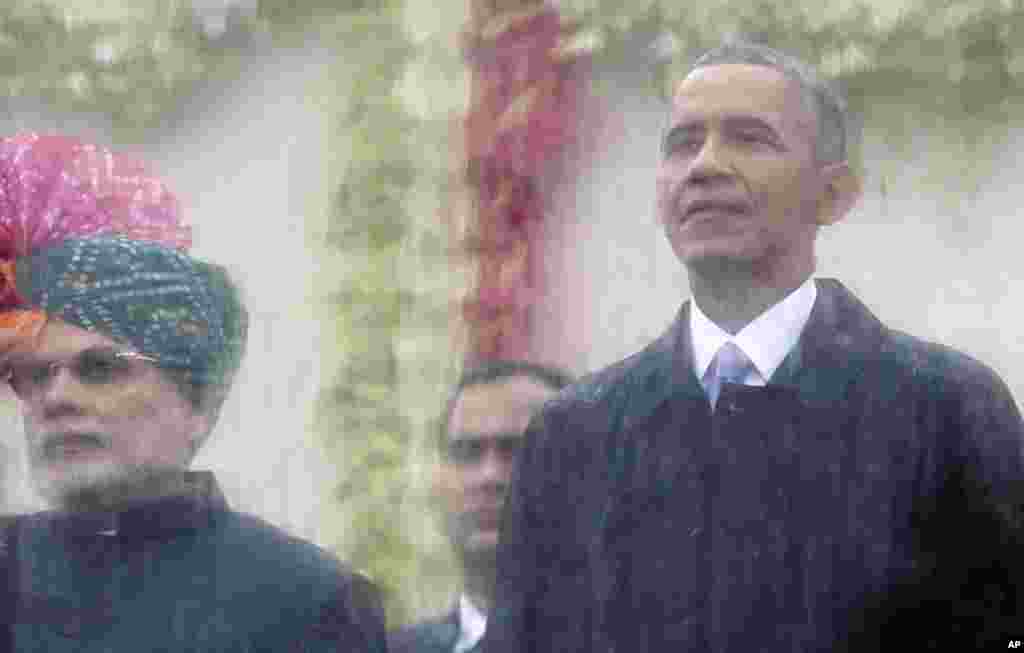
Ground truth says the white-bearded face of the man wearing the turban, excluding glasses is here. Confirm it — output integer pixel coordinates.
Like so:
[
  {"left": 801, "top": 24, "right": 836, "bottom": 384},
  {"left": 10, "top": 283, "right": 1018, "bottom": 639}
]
[{"left": 11, "top": 320, "right": 205, "bottom": 505}]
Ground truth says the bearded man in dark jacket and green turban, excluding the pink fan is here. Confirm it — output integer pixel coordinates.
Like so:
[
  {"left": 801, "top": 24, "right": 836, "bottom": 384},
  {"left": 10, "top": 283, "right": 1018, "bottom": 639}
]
[{"left": 0, "top": 235, "right": 385, "bottom": 653}]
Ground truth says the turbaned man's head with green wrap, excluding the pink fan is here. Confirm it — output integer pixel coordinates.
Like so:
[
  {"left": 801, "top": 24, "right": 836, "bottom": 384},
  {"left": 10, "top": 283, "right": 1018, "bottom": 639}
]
[{"left": 4, "top": 235, "right": 247, "bottom": 510}]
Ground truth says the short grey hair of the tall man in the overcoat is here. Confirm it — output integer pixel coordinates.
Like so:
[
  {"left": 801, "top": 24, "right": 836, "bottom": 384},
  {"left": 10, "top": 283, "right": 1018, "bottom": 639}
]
[{"left": 690, "top": 39, "right": 851, "bottom": 163}]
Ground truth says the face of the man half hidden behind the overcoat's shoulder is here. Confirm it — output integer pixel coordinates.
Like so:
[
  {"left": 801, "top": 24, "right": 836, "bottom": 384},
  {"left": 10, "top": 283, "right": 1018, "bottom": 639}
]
[{"left": 439, "top": 377, "right": 555, "bottom": 556}]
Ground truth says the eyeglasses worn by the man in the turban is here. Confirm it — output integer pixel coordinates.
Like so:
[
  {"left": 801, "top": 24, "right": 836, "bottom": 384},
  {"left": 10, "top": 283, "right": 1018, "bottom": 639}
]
[{"left": 0, "top": 347, "right": 157, "bottom": 399}]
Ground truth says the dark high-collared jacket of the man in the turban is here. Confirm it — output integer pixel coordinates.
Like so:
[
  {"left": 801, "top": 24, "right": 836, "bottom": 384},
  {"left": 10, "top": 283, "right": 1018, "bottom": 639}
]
[{"left": 8, "top": 475, "right": 385, "bottom": 653}]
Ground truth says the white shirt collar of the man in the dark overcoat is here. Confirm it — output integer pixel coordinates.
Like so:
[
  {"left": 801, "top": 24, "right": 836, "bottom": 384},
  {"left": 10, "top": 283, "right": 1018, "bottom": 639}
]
[{"left": 690, "top": 277, "right": 818, "bottom": 385}]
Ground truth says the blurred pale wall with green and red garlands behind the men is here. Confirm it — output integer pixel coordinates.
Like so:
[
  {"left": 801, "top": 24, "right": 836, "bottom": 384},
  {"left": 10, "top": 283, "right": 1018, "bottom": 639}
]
[{"left": 0, "top": 0, "right": 1024, "bottom": 622}]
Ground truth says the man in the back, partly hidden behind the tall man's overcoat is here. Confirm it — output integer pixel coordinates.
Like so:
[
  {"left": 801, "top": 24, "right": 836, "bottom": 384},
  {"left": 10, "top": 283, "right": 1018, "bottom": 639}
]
[{"left": 388, "top": 360, "right": 569, "bottom": 653}]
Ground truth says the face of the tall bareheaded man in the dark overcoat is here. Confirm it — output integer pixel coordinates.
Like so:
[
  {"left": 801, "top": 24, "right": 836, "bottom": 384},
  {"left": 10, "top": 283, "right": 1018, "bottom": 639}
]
[{"left": 656, "top": 63, "right": 824, "bottom": 265}]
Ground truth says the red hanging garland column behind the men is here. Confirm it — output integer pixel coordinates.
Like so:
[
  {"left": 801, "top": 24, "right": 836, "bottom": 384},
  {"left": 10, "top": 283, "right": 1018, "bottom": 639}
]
[{"left": 463, "top": 0, "right": 583, "bottom": 359}]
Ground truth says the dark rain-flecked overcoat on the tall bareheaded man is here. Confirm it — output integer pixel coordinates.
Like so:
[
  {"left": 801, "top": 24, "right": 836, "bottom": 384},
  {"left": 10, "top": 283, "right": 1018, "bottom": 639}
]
[{"left": 484, "top": 280, "right": 1024, "bottom": 653}]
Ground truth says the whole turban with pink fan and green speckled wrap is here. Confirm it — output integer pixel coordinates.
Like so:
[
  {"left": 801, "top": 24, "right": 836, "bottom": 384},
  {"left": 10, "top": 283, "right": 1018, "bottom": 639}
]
[{"left": 0, "top": 134, "right": 247, "bottom": 393}]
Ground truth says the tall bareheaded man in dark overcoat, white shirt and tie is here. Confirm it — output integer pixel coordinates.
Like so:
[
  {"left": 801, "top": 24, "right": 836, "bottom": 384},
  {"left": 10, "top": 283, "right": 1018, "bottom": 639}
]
[{"left": 484, "top": 42, "right": 1024, "bottom": 653}]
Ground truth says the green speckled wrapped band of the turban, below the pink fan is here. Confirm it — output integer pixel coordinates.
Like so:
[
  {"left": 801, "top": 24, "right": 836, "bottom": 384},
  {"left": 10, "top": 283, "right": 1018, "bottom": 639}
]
[{"left": 15, "top": 235, "right": 248, "bottom": 393}]
